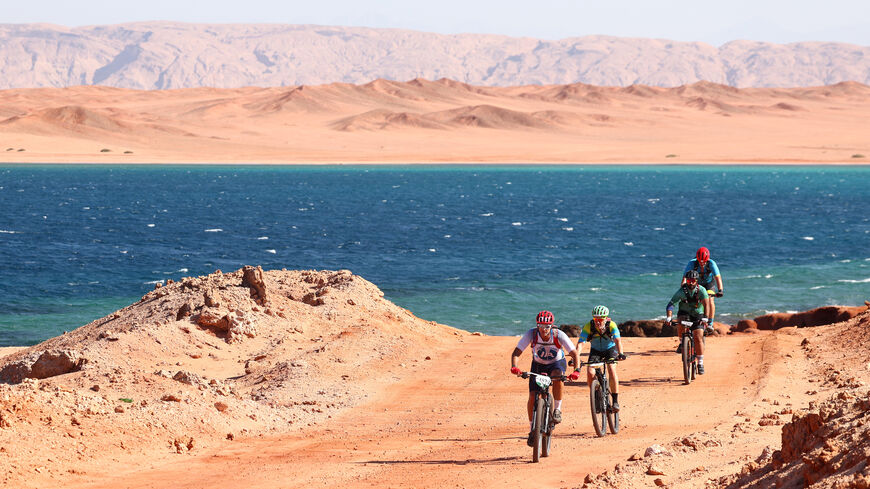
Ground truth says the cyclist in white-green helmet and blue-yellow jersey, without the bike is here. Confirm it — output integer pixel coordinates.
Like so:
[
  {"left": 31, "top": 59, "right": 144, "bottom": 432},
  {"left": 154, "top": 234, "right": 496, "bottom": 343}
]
[{"left": 575, "top": 306, "right": 626, "bottom": 413}]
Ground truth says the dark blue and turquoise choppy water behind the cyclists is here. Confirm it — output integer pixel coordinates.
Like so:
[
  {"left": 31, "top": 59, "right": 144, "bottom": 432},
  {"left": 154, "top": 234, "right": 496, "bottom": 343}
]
[{"left": 0, "top": 165, "right": 870, "bottom": 345}]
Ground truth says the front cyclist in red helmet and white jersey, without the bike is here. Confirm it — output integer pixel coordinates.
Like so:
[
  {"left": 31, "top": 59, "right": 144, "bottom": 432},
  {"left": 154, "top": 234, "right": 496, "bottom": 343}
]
[{"left": 511, "top": 311, "right": 580, "bottom": 446}]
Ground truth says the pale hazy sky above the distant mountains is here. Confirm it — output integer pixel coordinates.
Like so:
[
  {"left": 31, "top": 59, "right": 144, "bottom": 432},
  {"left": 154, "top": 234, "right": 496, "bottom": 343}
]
[{"left": 6, "top": 0, "right": 870, "bottom": 46}]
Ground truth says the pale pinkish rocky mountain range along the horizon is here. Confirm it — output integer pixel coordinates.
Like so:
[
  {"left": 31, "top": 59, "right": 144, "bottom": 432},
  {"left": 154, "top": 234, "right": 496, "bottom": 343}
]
[{"left": 0, "top": 21, "right": 870, "bottom": 90}]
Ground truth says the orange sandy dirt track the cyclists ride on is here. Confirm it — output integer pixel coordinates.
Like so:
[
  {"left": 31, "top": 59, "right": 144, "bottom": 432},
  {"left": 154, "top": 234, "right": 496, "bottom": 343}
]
[{"left": 68, "top": 328, "right": 808, "bottom": 488}]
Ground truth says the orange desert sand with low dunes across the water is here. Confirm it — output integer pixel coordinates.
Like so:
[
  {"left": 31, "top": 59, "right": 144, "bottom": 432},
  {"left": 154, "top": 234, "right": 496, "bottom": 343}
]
[{"left": 0, "top": 79, "right": 870, "bottom": 164}]
